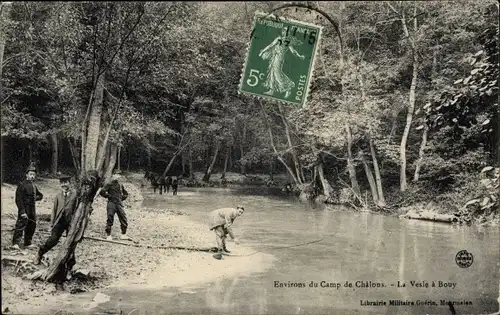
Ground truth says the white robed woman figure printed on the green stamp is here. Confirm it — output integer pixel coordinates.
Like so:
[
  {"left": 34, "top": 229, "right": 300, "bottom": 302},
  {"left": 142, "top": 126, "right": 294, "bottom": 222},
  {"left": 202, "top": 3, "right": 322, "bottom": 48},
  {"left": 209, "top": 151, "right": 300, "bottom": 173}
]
[{"left": 259, "top": 28, "right": 305, "bottom": 98}]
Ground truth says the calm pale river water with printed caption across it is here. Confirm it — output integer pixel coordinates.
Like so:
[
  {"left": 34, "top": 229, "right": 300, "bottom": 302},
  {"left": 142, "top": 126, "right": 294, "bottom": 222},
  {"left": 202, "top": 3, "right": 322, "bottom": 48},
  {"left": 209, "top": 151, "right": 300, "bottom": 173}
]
[{"left": 62, "top": 188, "right": 499, "bottom": 315}]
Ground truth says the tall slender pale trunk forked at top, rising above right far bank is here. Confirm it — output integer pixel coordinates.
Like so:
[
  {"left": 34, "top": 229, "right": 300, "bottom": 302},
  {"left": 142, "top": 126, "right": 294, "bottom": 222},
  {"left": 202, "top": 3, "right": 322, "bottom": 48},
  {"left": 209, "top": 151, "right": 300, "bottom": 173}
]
[{"left": 399, "top": 7, "right": 419, "bottom": 191}]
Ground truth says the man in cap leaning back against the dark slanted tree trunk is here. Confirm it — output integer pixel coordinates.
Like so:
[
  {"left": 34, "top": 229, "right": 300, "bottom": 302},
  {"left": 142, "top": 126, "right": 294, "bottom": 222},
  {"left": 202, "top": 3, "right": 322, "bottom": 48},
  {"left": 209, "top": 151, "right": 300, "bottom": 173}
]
[{"left": 33, "top": 176, "right": 77, "bottom": 265}]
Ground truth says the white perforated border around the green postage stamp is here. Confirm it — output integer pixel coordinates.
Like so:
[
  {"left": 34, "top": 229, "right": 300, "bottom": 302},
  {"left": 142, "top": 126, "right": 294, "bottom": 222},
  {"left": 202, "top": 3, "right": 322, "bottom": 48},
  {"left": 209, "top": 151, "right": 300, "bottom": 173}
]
[{"left": 238, "top": 11, "right": 323, "bottom": 107}]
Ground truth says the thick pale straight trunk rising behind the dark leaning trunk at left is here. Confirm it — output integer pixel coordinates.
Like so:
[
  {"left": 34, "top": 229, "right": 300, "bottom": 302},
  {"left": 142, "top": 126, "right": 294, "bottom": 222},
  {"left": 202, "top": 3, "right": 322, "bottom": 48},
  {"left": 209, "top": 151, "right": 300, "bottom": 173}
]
[{"left": 84, "top": 73, "right": 104, "bottom": 171}]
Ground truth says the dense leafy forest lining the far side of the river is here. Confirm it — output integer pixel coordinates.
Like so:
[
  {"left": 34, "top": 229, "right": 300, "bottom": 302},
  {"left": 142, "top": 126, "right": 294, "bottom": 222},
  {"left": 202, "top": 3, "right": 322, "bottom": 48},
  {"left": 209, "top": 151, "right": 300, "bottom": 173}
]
[{"left": 0, "top": 0, "right": 500, "bottom": 222}]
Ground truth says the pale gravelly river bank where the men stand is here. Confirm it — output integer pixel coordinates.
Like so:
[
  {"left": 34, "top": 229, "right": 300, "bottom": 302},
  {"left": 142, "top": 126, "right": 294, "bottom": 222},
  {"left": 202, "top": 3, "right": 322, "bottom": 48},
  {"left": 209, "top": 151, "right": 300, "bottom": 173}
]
[{"left": 1, "top": 174, "right": 273, "bottom": 314}]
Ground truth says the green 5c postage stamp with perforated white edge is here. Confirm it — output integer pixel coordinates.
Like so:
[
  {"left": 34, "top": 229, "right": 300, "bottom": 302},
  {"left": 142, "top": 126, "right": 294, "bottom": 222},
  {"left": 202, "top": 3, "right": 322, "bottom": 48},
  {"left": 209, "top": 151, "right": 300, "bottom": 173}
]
[{"left": 238, "top": 13, "right": 322, "bottom": 106}]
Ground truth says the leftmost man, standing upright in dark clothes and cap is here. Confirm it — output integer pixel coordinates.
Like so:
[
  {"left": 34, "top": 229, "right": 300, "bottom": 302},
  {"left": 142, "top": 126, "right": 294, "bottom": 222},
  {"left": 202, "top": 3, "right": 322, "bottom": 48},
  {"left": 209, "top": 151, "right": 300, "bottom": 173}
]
[{"left": 12, "top": 165, "right": 43, "bottom": 249}]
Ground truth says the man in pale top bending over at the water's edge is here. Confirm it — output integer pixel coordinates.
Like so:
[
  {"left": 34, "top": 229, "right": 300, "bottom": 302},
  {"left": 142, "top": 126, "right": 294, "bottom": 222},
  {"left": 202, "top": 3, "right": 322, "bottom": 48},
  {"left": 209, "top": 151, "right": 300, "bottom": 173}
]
[{"left": 209, "top": 206, "right": 245, "bottom": 253}]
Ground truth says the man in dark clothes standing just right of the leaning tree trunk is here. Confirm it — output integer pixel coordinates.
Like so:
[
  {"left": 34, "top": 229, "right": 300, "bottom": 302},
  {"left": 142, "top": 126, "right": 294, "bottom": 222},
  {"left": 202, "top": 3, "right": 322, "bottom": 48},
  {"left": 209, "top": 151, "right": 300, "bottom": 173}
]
[{"left": 100, "top": 172, "right": 130, "bottom": 240}]
